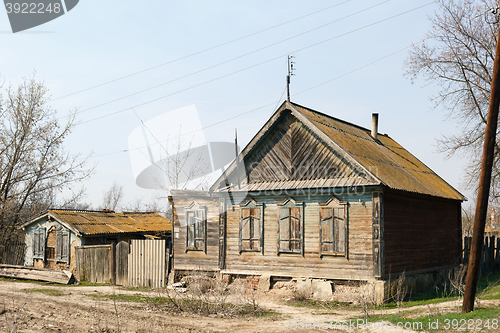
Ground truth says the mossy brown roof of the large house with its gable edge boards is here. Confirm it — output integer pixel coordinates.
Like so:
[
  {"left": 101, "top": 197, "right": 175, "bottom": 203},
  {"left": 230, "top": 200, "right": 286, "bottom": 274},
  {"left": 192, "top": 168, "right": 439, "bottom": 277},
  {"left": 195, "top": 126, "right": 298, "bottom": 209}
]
[{"left": 211, "top": 101, "right": 465, "bottom": 201}]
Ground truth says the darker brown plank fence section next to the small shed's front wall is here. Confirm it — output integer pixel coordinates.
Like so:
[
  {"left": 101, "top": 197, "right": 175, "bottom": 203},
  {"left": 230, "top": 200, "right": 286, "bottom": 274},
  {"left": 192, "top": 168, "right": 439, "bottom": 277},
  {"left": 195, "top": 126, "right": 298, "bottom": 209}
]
[{"left": 75, "top": 244, "right": 115, "bottom": 283}]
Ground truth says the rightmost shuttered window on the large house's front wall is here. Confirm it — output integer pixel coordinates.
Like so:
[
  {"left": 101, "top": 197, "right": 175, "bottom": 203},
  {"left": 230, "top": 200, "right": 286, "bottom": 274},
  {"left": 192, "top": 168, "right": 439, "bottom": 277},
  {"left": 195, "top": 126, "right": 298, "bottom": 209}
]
[{"left": 319, "top": 196, "right": 349, "bottom": 258}]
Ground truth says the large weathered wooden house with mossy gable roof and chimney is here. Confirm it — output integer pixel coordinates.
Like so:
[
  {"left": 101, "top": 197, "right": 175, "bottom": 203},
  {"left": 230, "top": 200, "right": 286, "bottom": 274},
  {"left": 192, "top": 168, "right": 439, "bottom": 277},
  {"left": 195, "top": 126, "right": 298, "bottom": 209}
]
[{"left": 170, "top": 101, "right": 465, "bottom": 296}]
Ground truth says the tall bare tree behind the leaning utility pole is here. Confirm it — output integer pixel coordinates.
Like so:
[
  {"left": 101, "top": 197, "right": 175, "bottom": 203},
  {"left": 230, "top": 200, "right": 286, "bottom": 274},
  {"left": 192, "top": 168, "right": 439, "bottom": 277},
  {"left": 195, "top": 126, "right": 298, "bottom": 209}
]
[{"left": 406, "top": 0, "right": 500, "bottom": 198}]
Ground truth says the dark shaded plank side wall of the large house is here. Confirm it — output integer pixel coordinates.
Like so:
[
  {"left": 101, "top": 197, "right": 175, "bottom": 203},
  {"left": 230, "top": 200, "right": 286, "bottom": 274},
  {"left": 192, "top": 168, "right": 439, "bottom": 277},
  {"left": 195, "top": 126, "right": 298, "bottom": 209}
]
[{"left": 383, "top": 191, "right": 462, "bottom": 276}]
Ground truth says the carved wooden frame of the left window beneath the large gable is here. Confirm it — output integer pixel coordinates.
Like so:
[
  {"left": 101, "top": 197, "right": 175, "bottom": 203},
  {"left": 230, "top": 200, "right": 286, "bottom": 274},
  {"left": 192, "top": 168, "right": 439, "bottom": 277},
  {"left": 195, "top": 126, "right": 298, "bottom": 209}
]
[{"left": 239, "top": 199, "right": 264, "bottom": 254}]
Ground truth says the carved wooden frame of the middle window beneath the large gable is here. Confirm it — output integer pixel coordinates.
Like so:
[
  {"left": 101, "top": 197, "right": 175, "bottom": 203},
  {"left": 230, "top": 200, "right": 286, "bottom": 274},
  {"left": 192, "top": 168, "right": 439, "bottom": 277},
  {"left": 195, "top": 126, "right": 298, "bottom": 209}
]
[{"left": 277, "top": 198, "right": 305, "bottom": 256}]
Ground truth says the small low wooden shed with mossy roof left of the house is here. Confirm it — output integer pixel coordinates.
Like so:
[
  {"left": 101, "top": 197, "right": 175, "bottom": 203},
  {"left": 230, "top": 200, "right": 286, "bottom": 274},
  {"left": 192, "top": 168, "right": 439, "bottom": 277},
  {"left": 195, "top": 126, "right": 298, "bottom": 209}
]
[{"left": 21, "top": 209, "right": 172, "bottom": 276}]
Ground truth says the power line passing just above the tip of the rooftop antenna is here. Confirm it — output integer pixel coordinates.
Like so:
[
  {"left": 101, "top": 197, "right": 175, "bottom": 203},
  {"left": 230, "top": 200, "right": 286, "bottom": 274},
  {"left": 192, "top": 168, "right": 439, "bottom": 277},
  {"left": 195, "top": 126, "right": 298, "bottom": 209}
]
[{"left": 75, "top": 1, "right": 435, "bottom": 126}]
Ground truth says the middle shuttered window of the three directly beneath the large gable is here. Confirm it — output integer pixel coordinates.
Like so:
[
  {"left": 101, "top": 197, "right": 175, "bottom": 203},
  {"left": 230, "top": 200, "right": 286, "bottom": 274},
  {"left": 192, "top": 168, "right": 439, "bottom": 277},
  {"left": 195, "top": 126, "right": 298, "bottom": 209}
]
[{"left": 278, "top": 198, "right": 304, "bottom": 254}]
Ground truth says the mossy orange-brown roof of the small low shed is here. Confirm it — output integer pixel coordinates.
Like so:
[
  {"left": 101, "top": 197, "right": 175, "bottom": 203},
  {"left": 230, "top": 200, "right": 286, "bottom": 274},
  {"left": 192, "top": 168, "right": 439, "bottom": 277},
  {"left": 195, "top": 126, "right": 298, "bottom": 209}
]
[{"left": 21, "top": 209, "right": 172, "bottom": 236}]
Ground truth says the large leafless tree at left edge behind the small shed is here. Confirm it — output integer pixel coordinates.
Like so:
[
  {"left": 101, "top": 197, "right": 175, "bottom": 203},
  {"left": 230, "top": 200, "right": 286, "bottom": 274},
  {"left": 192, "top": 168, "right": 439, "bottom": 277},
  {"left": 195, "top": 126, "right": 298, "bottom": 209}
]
[{"left": 0, "top": 78, "right": 91, "bottom": 242}]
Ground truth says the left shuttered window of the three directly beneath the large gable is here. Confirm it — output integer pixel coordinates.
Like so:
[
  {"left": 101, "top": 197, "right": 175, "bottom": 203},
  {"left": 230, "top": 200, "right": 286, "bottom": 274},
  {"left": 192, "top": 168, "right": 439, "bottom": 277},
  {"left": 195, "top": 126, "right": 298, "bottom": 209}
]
[{"left": 240, "top": 199, "right": 264, "bottom": 253}]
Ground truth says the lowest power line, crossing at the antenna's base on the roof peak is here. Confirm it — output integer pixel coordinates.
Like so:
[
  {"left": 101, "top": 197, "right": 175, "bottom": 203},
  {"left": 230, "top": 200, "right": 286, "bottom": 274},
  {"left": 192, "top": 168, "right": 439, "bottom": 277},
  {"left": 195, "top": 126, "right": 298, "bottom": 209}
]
[{"left": 93, "top": 36, "right": 433, "bottom": 158}]
